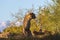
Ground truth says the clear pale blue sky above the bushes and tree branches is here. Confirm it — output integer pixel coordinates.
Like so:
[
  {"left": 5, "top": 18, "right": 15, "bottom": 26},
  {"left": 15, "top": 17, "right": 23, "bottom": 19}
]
[{"left": 0, "top": 0, "right": 53, "bottom": 21}]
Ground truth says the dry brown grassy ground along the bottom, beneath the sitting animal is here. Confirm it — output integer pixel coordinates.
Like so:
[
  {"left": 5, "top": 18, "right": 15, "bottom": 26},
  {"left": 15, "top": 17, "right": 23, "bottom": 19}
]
[{"left": 0, "top": 33, "right": 60, "bottom": 40}]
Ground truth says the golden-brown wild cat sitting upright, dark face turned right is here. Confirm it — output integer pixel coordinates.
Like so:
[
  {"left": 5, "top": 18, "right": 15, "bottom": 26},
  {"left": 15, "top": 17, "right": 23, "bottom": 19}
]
[{"left": 23, "top": 13, "right": 36, "bottom": 36}]
